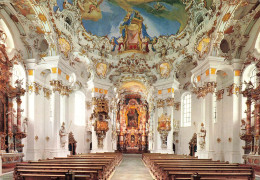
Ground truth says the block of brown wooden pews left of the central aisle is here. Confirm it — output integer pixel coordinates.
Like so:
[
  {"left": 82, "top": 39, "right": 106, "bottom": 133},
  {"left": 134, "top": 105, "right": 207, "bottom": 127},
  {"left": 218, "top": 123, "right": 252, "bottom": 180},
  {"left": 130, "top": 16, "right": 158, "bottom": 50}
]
[{"left": 14, "top": 153, "right": 122, "bottom": 180}]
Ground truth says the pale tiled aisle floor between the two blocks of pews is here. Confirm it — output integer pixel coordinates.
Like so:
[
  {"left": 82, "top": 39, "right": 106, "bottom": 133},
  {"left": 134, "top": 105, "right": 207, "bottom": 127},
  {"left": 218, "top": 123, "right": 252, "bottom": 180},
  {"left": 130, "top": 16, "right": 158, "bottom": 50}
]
[{"left": 111, "top": 154, "right": 153, "bottom": 180}]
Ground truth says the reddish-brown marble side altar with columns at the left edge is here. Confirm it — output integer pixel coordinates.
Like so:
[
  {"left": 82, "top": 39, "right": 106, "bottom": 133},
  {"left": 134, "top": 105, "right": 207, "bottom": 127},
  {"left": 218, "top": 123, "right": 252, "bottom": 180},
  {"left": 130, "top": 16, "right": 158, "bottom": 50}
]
[{"left": 0, "top": 35, "right": 26, "bottom": 171}]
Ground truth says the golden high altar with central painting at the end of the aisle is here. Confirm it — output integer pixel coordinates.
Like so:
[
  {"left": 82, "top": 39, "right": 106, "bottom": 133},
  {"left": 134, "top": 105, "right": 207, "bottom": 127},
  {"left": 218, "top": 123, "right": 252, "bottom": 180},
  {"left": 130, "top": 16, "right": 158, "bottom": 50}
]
[{"left": 117, "top": 96, "right": 148, "bottom": 153}]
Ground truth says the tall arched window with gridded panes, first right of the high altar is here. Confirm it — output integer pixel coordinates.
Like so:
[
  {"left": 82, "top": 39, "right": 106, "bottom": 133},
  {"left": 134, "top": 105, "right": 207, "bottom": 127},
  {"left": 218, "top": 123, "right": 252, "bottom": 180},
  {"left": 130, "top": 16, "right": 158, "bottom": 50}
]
[{"left": 182, "top": 93, "right": 191, "bottom": 127}]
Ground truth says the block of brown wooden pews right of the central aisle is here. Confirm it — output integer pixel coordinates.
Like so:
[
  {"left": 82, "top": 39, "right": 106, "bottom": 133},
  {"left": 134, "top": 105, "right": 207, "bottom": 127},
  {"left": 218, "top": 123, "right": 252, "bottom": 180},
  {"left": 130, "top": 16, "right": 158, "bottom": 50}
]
[{"left": 143, "top": 154, "right": 254, "bottom": 180}]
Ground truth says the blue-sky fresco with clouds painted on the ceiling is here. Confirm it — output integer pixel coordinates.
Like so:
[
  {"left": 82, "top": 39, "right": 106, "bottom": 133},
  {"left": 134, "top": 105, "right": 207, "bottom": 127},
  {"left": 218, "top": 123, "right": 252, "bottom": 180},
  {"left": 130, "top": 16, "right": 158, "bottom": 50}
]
[{"left": 54, "top": 0, "right": 191, "bottom": 38}]
